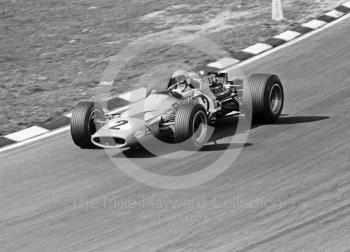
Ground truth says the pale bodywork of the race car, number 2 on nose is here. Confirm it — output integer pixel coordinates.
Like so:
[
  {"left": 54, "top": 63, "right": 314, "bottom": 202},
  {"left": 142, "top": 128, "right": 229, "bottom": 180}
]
[{"left": 91, "top": 68, "right": 241, "bottom": 148}]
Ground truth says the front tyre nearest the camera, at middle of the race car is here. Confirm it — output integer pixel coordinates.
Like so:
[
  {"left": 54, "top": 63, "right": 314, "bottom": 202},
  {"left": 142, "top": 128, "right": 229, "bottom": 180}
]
[{"left": 174, "top": 104, "right": 208, "bottom": 150}]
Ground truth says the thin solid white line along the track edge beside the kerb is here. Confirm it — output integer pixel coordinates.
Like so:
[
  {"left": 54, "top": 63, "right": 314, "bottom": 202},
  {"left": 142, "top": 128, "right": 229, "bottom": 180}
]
[{"left": 0, "top": 12, "right": 350, "bottom": 153}]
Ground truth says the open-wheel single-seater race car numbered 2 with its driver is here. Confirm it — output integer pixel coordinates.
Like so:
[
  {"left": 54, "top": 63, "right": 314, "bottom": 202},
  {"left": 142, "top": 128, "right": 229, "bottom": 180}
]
[{"left": 70, "top": 59, "right": 284, "bottom": 150}]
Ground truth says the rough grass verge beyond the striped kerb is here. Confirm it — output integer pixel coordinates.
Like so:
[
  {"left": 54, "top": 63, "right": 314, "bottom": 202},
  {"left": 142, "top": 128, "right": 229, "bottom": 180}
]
[{"left": 0, "top": 0, "right": 344, "bottom": 135}]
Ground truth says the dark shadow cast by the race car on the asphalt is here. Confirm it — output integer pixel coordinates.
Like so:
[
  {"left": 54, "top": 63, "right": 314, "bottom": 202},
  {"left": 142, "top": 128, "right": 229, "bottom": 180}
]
[{"left": 113, "top": 115, "right": 330, "bottom": 158}]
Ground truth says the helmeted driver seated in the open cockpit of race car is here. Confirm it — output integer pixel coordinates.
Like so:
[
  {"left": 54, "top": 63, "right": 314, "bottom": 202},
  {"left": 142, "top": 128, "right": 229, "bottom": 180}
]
[{"left": 171, "top": 70, "right": 193, "bottom": 97}]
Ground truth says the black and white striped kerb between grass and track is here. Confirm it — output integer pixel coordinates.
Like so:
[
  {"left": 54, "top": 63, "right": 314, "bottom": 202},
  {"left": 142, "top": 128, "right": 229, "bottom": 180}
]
[{"left": 0, "top": 1, "right": 350, "bottom": 148}]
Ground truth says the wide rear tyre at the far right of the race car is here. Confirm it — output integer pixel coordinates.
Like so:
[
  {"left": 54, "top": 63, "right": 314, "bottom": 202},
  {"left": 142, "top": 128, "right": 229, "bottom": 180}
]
[{"left": 243, "top": 74, "right": 284, "bottom": 123}]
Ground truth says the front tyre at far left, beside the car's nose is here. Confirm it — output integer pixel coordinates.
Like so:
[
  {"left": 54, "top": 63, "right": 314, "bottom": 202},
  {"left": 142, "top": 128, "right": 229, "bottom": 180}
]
[{"left": 70, "top": 101, "right": 104, "bottom": 149}]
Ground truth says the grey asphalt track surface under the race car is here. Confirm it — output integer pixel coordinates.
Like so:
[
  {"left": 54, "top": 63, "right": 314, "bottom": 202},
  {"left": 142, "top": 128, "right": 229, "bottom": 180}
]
[{"left": 0, "top": 19, "right": 350, "bottom": 251}]
